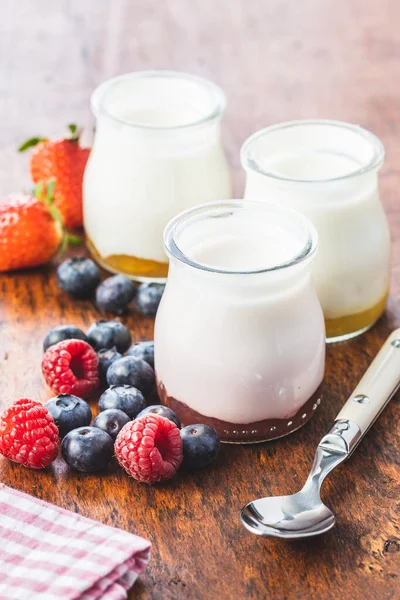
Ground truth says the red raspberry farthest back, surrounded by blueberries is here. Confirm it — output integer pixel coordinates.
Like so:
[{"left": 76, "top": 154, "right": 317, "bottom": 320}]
[{"left": 42, "top": 339, "right": 99, "bottom": 398}]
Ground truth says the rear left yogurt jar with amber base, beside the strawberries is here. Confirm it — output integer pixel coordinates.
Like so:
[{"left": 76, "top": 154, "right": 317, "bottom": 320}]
[{"left": 83, "top": 71, "right": 231, "bottom": 282}]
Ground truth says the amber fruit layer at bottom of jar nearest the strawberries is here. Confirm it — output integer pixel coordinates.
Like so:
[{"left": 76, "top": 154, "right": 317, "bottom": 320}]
[{"left": 86, "top": 238, "right": 168, "bottom": 279}]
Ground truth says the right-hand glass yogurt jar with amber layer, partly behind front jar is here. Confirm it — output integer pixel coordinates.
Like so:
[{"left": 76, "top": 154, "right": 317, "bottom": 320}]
[{"left": 241, "top": 120, "right": 390, "bottom": 341}]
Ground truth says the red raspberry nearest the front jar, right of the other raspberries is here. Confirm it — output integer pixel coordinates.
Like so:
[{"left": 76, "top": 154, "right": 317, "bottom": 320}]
[{"left": 114, "top": 414, "right": 183, "bottom": 483}]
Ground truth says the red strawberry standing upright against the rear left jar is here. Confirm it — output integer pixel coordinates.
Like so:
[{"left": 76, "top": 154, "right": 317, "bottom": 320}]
[{"left": 18, "top": 125, "right": 90, "bottom": 228}]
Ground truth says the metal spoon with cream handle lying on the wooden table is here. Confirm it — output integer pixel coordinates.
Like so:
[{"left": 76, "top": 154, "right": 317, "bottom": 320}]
[{"left": 240, "top": 329, "right": 400, "bottom": 539}]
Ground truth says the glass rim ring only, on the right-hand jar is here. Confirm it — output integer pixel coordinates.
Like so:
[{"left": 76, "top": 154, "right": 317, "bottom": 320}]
[{"left": 240, "top": 119, "right": 385, "bottom": 184}]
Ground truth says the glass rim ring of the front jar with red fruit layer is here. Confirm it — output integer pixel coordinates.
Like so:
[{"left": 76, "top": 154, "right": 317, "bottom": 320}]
[{"left": 164, "top": 200, "right": 318, "bottom": 275}]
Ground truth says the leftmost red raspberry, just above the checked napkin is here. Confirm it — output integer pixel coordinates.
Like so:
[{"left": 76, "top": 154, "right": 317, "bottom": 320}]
[{"left": 0, "top": 398, "right": 60, "bottom": 469}]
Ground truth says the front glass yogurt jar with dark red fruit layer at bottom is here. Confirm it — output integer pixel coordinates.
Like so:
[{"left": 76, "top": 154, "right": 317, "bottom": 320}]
[{"left": 154, "top": 200, "right": 325, "bottom": 443}]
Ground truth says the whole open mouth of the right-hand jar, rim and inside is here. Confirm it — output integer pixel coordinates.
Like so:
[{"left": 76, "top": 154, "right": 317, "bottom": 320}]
[{"left": 241, "top": 120, "right": 384, "bottom": 185}]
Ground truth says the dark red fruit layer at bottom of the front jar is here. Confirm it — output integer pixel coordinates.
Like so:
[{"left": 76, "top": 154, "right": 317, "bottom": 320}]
[{"left": 157, "top": 381, "right": 323, "bottom": 444}]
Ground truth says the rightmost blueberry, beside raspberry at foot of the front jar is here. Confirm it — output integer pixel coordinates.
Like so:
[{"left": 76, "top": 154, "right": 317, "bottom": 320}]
[{"left": 181, "top": 425, "right": 220, "bottom": 469}]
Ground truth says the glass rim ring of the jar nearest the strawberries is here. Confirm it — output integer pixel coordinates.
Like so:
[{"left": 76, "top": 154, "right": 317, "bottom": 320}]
[{"left": 90, "top": 69, "right": 226, "bottom": 131}]
